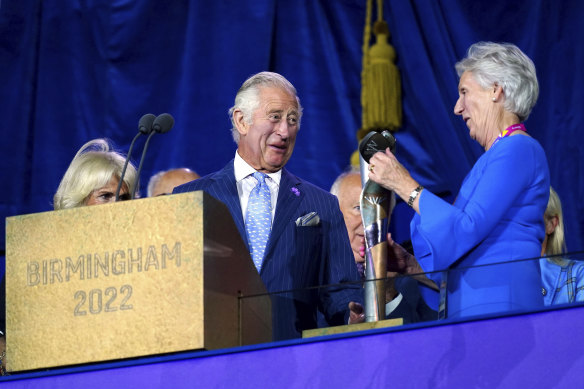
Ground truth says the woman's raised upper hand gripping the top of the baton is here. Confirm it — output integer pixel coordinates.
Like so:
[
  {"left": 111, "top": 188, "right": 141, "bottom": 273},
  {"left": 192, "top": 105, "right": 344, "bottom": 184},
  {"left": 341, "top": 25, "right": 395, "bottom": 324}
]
[{"left": 369, "top": 148, "right": 418, "bottom": 202}]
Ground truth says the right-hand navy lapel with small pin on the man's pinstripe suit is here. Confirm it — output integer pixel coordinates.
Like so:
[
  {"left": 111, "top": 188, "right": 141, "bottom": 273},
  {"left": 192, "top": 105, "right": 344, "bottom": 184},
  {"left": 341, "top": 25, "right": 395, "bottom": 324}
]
[{"left": 264, "top": 169, "right": 304, "bottom": 260}]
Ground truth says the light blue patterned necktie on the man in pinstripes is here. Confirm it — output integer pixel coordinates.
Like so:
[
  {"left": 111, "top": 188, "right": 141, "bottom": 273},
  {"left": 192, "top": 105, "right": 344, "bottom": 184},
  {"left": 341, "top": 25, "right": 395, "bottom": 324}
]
[{"left": 245, "top": 172, "right": 272, "bottom": 273}]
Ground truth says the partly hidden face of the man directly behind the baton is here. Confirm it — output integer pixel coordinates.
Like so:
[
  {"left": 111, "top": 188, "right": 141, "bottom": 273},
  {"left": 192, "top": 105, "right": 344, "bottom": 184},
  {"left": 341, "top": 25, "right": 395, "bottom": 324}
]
[{"left": 339, "top": 174, "right": 365, "bottom": 262}]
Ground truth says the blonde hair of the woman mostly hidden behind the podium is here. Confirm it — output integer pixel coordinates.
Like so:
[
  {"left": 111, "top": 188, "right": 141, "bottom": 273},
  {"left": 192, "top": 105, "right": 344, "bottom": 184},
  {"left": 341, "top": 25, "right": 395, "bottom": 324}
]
[{"left": 53, "top": 139, "right": 137, "bottom": 210}]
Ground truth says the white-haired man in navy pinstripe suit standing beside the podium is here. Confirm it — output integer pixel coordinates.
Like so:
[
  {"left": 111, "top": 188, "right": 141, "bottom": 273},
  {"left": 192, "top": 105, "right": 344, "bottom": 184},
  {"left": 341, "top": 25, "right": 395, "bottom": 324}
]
[{"left": 173, "top": 72, "right": 363, "bottom": 340}]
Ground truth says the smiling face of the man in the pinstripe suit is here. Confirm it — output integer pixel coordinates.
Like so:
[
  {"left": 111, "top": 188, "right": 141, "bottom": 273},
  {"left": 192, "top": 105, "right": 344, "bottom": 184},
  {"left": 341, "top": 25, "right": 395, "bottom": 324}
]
[{"left": 233, "top": 87, "right": 299, "bottom": 173}]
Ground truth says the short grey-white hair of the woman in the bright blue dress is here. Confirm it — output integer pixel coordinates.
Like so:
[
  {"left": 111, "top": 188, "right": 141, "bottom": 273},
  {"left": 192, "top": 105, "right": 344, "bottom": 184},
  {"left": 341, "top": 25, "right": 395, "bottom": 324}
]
[{"left": 455, "top": 42, "right": 539, "bottom": 121}]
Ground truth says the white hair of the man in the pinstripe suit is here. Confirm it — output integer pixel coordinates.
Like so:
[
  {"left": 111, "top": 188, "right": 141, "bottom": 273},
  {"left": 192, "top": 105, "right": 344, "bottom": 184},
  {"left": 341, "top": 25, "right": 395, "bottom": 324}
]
[{"left": 229, "top": 72, "right": 302, "bottom": 144}]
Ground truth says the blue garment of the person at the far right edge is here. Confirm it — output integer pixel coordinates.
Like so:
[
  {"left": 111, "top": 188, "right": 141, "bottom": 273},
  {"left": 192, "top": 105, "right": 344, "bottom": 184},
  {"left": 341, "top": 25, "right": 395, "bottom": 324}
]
[{"left": 539, "top": 258, "right": 584, "bottom": 305}]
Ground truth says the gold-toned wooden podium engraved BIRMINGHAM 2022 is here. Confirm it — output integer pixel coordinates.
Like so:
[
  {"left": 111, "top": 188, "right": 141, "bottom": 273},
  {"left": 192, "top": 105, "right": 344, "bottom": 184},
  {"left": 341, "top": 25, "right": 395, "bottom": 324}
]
[{"left": 6, "top": 191, "right": 272, "bottom": 371}]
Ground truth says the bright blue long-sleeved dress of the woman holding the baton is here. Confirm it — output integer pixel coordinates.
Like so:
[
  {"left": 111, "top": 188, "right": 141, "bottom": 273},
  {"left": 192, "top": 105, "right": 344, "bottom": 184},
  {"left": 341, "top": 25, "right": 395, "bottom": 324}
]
[{"left": 410, "top": 135, "right": 550, "bottom": 318}]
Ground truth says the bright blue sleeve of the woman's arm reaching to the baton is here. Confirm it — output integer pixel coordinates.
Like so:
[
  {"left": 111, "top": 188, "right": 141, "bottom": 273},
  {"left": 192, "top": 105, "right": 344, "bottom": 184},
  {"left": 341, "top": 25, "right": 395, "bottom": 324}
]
[{"left": 411, "top": 135, "right": 543, "bottom": 272}]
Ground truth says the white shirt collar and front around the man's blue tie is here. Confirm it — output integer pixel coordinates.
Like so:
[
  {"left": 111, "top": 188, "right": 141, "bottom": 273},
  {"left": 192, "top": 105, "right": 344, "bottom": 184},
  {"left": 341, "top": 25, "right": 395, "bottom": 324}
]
[{"left": 233, "top": 151, "right": 282, "bottom": 224}]
